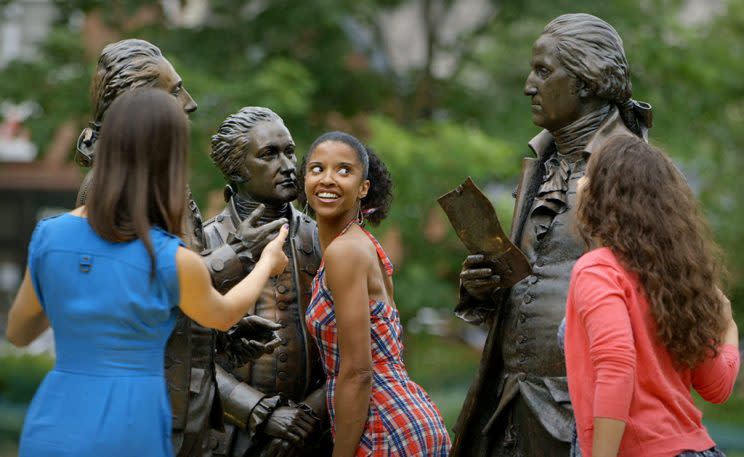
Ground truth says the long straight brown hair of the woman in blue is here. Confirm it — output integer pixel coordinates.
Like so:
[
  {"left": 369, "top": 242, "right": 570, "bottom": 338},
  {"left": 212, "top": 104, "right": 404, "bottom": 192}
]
[{"left": 86, "top": 89, "right": 189, "bottom": 275}]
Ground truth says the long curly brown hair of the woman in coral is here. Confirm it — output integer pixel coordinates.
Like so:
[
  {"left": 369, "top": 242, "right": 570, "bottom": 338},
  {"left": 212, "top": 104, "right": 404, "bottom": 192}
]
[{"left": 577, "top": 136, "right": 726, "bottom": 368}]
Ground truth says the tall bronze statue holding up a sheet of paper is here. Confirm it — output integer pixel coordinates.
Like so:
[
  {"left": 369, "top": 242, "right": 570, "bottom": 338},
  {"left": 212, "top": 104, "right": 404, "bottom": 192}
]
[{"left": 452, "top": 14, "right": 651, "bottom": 457}]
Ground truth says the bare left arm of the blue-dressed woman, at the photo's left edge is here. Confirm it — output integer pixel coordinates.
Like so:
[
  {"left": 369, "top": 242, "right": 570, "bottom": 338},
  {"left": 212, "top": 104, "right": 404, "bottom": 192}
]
[{"left": 6, "top": 268, "right": 49, "bottom": 346}]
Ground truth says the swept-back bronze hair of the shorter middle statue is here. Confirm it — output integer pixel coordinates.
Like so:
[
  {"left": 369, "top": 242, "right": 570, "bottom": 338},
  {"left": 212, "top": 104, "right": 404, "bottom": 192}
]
[{"left": 209, "top": 106, "right": 284, "bottom": 180}]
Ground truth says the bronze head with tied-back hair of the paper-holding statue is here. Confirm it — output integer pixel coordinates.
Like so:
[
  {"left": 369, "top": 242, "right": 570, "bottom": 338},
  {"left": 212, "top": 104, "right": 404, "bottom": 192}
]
[{"left": 524, "top": 14, "right": 650, "bottom": 134}]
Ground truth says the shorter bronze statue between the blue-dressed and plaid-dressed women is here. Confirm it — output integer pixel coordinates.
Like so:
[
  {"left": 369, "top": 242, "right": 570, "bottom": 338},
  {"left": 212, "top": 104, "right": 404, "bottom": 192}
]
[{"left": 203, "top": 107, "right": 331, "bottom": 457}]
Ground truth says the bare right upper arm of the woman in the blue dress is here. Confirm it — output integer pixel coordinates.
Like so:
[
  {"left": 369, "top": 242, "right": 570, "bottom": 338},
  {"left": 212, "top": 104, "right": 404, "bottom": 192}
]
[{"left": 176, "top": 247, "right": 224, "bottom": 328}]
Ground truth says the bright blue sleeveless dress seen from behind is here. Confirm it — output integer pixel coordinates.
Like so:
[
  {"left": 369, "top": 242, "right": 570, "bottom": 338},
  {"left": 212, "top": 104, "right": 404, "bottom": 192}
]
[{"left": 19, "top": 213, "right": 183, "bottom": 457}]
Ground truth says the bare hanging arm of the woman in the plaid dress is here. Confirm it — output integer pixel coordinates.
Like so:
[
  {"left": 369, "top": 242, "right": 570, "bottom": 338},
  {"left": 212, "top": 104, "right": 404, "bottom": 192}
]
[{"left": 324, "top": 238, "right": 373, "bottom": 457}]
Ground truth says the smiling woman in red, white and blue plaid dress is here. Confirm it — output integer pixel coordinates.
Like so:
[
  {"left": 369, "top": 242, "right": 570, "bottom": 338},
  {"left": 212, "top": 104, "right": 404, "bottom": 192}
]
[{"left": 302, "top": 132, "right": 450, "bottom": 457}]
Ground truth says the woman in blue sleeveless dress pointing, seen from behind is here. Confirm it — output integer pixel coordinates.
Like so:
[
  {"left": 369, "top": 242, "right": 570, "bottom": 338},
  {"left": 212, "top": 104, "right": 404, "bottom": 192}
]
[{"left": 7, "top": 89, "right": 287, "bottom": 457}]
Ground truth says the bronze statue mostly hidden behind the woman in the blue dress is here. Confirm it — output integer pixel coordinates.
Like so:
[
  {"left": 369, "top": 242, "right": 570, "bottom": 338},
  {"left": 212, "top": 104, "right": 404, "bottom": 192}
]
[{"left": 75, "top": 39, "right": 275, "bottom": 457}]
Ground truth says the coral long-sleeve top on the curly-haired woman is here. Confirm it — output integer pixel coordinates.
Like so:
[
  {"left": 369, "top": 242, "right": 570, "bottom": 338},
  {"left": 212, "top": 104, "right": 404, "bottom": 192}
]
[{"left": 565, "top": 248, "right": 740, "bottom": 457}]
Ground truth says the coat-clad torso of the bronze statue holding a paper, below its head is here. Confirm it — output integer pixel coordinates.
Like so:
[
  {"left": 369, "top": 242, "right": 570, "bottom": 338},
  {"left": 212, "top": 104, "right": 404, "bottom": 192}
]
[{"left": 453, "top": 111, "right": 632, "bottom": 457}]
